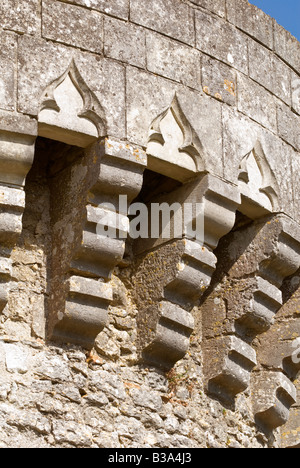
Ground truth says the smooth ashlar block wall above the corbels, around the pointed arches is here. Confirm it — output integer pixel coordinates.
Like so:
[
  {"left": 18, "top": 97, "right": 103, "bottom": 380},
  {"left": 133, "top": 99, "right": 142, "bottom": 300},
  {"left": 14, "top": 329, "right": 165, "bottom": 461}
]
[{"left": 0, "top": 0, "right": 300, "bottom": 220}]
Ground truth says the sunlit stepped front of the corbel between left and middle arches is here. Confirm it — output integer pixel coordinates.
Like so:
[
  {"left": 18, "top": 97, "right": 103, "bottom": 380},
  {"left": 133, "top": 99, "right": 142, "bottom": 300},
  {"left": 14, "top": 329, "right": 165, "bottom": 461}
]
[{"left": 51, "top": 138, "right": 146, "bottom": 348}]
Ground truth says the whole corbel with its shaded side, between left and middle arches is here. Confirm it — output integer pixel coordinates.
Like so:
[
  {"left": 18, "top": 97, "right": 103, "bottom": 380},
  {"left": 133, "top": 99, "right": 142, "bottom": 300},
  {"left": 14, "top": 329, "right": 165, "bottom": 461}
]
[{"left": 49, "top": 138, "right": 145, "bottom": 349}]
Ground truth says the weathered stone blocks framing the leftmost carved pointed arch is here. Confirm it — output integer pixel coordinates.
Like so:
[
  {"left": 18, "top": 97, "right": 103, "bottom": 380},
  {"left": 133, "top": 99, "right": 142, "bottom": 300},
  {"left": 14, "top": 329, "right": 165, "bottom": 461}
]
[{"left": 18, "top": 36, "right": 125, "bottom": 138}]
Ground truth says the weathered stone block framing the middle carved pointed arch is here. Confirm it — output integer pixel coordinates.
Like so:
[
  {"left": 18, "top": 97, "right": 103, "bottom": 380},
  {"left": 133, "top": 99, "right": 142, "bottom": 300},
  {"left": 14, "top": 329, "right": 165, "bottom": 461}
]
[{"left": 126, "top": 68, "right": 222, "bottom": 171}]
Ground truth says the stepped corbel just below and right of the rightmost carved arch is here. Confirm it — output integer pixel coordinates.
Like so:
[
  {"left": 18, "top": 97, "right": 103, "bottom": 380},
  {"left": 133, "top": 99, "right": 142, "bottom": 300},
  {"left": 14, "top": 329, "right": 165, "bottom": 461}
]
[{"left": 202, "top": 215, "right": 300, "bottom": 401}]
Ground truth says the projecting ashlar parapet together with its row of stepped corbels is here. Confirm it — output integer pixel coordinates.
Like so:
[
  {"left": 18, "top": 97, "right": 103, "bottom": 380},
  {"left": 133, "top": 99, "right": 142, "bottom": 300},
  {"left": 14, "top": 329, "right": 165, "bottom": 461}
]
[{"left": 0, "top": 0, "right": 300, "bottom": 446}]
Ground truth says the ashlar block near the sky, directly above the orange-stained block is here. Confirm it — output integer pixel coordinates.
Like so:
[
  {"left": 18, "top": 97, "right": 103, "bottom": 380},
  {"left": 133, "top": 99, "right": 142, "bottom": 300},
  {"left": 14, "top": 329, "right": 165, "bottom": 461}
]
[{"left": 195, "top": 11, "right": 248, "bottom": 73}]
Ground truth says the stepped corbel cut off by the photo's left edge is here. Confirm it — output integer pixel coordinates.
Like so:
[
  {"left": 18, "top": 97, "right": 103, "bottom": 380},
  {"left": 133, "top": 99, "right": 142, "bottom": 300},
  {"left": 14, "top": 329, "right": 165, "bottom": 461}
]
[{"left": 0, "top": 132, "right": 35, "bottom": 311}]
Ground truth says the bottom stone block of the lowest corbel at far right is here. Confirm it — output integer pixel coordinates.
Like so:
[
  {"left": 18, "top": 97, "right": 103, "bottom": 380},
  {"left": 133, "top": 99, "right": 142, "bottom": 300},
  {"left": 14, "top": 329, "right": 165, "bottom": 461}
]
[{"left": 252, "top": 371, "right": 297, "bottom": 432}]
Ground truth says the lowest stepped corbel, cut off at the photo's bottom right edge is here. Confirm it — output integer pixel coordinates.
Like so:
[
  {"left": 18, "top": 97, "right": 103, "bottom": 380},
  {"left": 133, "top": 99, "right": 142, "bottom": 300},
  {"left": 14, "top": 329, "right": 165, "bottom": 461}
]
[{"left": 251, "top": 296, "right": 300, "bottom": 436}]
